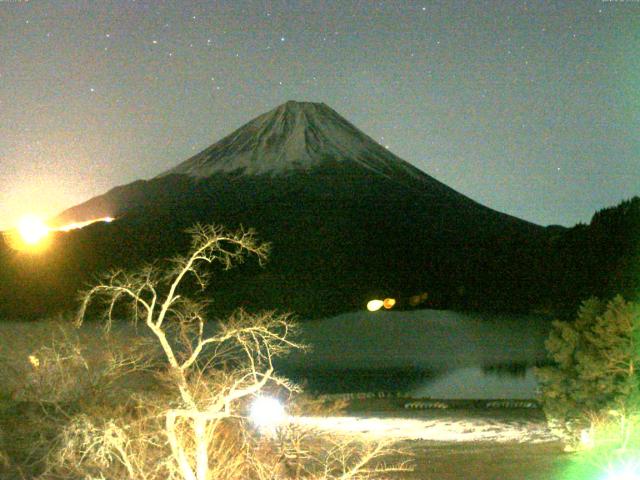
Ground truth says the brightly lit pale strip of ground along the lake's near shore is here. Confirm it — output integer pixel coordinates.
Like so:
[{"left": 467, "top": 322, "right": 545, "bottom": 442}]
[{"left": 290, "top": 416, "right": 557, "bottom": 443}]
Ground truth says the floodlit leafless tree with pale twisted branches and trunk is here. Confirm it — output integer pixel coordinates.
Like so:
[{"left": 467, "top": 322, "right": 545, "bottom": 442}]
[{"left": 78, "top": 225, "right": 302, "bottom": 480}]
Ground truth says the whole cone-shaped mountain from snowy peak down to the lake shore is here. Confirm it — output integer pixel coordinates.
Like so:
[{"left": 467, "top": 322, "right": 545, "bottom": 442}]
[{"left": 0, "top": 101, "right": 551, "bottom": 317}]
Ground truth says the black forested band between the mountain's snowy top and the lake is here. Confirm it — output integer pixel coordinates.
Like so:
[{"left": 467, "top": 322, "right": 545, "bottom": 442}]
[{"left": 0, "top": 174, "right": 640, "bottom": 319}]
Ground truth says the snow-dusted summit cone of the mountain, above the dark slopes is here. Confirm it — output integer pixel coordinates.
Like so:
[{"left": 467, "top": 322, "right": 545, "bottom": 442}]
[{"left": 159, "top": 101, "right": 423, "bottom": 178}]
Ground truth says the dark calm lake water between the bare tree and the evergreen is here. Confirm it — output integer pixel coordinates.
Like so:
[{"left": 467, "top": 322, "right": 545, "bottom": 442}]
[{"left": 282, "top": 310, "right": 551, "bottom": 399}]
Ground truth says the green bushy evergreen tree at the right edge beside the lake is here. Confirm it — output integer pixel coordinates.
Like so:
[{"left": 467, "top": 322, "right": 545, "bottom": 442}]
[{"left": 537, "top": 296, "right": 640, "bottom": 445}]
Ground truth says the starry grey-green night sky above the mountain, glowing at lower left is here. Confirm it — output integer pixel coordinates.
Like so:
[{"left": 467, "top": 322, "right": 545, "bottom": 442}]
[{"left": 0, "top": 0, "right": 640, "bottom": 228}]
